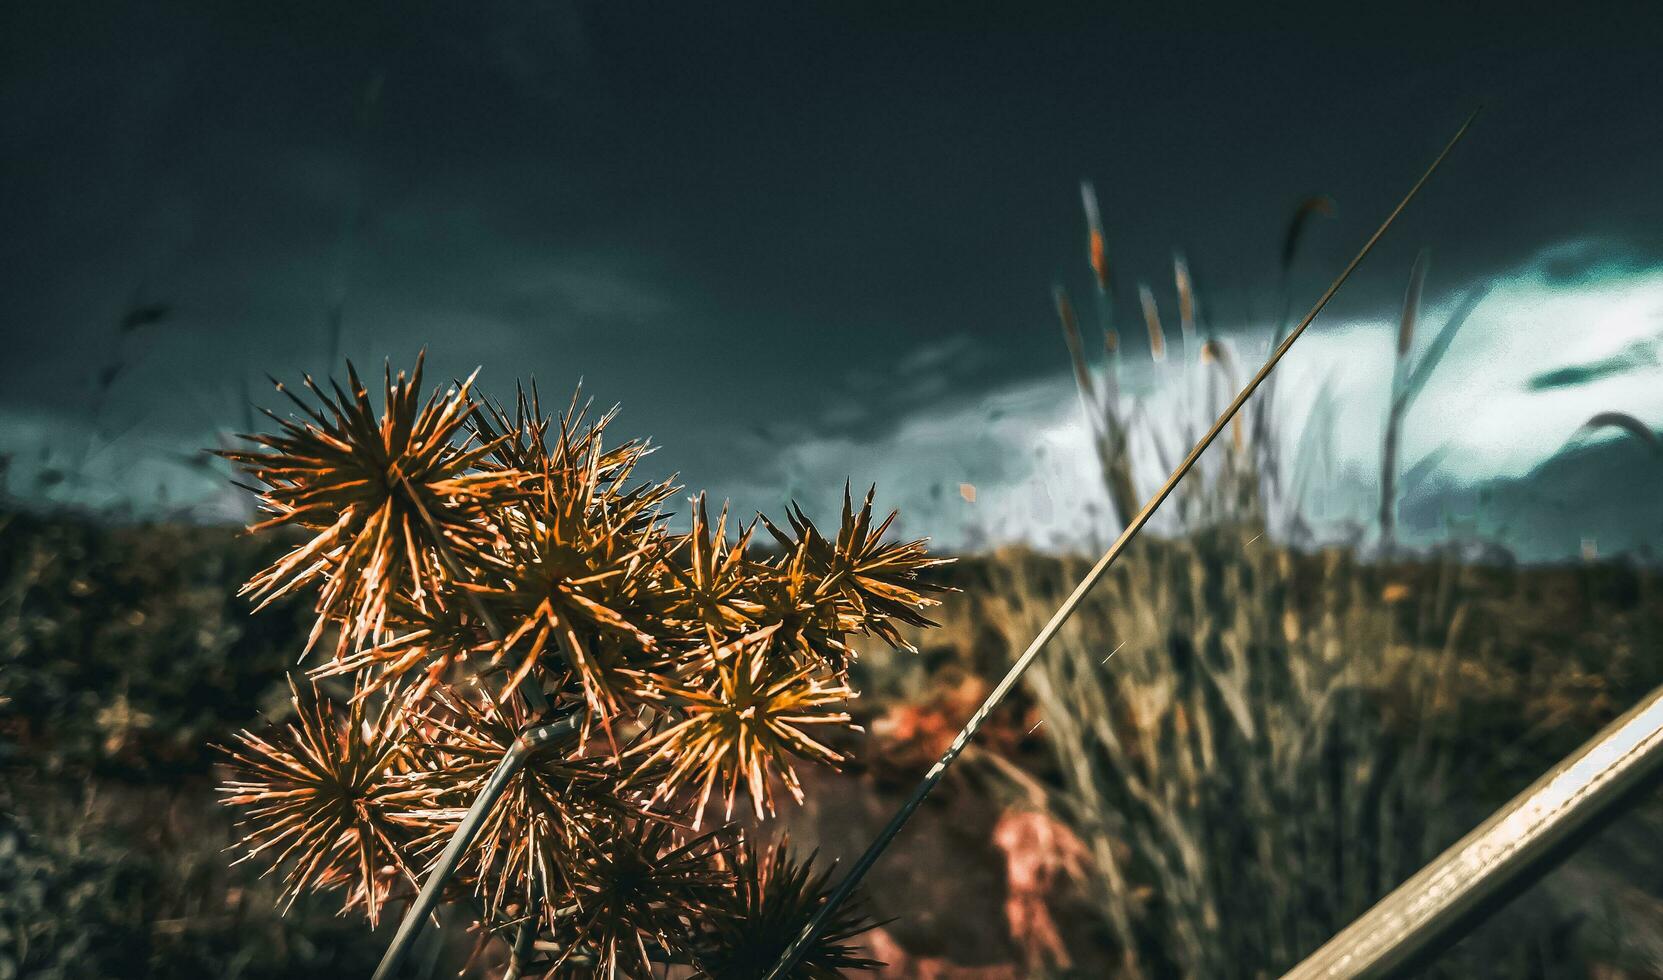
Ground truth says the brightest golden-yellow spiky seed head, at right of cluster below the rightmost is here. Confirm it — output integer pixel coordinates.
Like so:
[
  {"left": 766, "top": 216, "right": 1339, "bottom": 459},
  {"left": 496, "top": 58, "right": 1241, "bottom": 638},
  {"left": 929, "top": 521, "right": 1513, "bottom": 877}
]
[{"left": 634, "top": 627, "right": 855, "bottom": 829}]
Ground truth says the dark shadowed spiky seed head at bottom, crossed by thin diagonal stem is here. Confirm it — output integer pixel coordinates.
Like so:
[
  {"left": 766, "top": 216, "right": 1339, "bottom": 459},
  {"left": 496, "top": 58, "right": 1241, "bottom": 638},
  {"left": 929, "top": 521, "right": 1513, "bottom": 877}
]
[{"left": 692, "top": 840, "right": 881, "bottom": 980}]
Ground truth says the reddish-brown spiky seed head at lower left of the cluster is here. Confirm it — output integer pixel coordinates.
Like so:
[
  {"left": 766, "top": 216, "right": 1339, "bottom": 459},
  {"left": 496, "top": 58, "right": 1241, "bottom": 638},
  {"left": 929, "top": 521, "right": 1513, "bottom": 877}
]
[{"left": 220, "top": 681, "right": 422, "bottom": 925}]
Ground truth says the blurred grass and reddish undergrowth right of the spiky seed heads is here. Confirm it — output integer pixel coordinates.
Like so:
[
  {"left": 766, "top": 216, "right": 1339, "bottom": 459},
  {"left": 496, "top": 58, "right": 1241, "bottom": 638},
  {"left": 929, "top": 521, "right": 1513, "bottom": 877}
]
[{"left": 810, "top": 526, "right": 1663, "bottom": 980}]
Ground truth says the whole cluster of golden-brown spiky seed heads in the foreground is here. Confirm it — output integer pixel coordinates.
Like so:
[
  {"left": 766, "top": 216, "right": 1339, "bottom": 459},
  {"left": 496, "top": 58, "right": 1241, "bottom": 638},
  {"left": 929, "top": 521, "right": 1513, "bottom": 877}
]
[{"left": 225, "top": 359, "right": 941, "bottom": 977}]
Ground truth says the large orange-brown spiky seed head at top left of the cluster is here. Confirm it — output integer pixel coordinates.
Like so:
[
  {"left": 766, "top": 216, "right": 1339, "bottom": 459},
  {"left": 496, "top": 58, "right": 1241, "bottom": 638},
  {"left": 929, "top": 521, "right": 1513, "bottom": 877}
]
[{"left": 225, "top": 352, "right": 521, "bottom": 652}]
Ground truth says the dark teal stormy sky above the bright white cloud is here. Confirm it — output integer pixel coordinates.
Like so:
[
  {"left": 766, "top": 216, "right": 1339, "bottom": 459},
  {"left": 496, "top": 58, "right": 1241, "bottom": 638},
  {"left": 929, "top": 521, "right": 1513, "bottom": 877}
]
[{"left": 0, "top": 2, "right": 1663, "bottom": 542}]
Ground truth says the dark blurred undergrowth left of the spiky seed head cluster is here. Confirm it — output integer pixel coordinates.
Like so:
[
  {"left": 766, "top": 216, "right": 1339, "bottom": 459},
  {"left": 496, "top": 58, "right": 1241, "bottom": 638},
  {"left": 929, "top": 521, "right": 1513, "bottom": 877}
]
[{"left": 0, "top": 509, "right": 382, "bottom": 978}]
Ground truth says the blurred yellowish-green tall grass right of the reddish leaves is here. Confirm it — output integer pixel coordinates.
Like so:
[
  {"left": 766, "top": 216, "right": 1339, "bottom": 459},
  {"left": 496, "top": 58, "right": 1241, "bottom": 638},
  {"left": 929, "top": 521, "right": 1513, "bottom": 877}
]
[{"left": 957, "top": 539, "right": 1663, "bottom": 977}]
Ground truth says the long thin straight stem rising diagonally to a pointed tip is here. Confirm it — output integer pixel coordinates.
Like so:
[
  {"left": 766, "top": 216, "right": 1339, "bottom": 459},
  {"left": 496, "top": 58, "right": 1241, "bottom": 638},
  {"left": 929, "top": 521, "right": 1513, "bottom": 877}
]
[{"left": 767, "top": 111, "right": 1478, "bottom": 980}]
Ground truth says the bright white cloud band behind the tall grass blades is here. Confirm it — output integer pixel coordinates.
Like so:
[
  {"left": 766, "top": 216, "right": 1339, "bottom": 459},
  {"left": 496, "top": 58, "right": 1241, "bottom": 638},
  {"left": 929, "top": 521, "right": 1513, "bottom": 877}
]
[{"left": 701, "top": 247, "right": 1663, "bottom": 547}]
